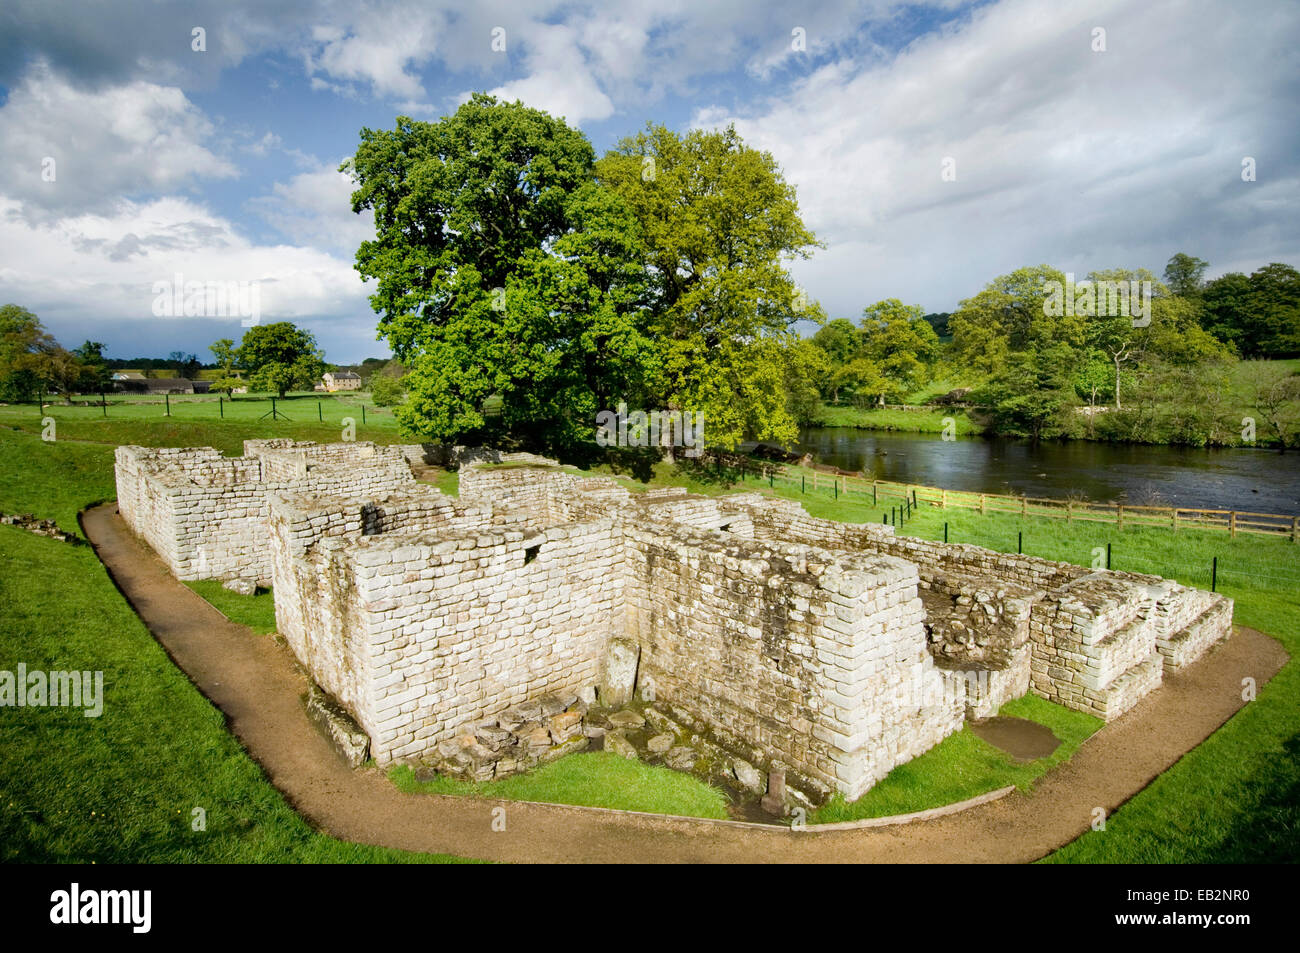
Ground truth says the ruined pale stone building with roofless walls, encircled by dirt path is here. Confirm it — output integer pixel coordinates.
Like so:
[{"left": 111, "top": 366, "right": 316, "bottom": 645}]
[{"left": 117, "top": 441, "right": 1232, "bottom": 803}]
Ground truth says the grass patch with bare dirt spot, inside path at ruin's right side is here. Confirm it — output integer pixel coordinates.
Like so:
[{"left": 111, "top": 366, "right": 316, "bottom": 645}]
[{"left": 809, "top": 694, "right": 1102, "bottom": 824}]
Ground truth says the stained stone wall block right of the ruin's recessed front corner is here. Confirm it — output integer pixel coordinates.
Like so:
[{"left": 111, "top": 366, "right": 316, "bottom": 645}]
[{"left": 627, "top": 527, "right": 965, "bottom": 798}]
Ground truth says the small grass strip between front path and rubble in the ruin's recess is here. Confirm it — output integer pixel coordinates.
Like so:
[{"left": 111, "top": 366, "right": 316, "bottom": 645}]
[{"left": 389, "top": 751, "right": 727, "bottom": 818}]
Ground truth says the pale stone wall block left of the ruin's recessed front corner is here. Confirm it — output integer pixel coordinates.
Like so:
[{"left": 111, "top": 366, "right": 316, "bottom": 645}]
[{"left": 272, "top": 486, "right": 621, "bottom": 763}]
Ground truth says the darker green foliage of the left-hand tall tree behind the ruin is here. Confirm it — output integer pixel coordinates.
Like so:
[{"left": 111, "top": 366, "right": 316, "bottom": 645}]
[{"left": 345, "top": 95, "right": 646, "bottom": 445}]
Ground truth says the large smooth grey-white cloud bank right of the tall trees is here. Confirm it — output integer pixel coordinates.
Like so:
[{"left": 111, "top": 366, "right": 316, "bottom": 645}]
[{"left": 693, "top": 0, "right": 1300, "bottom": 313}]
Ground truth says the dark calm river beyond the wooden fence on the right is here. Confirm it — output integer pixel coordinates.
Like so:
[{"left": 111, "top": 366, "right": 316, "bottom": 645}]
[{"left": 800, "top": 426, "right": 1300, "bottom": 514}]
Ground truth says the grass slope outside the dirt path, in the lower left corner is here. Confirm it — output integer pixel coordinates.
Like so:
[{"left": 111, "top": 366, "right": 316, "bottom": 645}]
[{"left": 0, "top": 525, "right": 467, "bottom": 863}]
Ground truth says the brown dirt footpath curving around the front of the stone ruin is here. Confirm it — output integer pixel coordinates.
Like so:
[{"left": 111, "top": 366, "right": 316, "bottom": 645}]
[{"left": 82, "top": 503, "right": 1287, "bottom": 863}]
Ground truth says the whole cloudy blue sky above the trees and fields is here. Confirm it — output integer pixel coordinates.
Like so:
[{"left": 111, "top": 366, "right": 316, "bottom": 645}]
[{"left": 0, "top": 0, "right": 1300, "bottom": 363}]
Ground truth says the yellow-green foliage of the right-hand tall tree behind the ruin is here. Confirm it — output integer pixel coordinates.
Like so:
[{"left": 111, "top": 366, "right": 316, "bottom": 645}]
[{"left": 597, "top": 124, "right": 822, "bottom": 447}]
